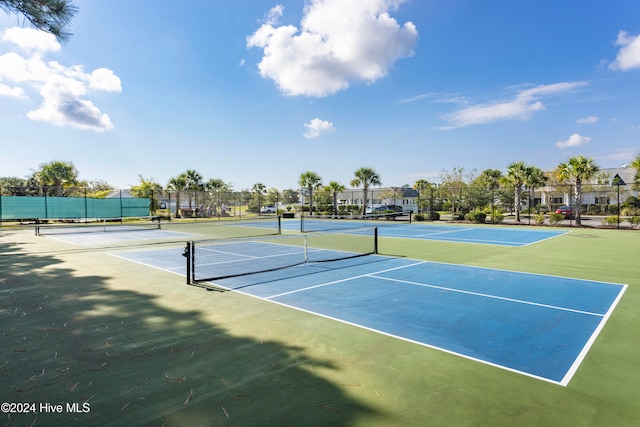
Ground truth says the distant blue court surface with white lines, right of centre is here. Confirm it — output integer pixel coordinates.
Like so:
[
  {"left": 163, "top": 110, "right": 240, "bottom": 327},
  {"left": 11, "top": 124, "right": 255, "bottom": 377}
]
[{"left": 282, "top": 218, "right": 567, "bottom": 247}]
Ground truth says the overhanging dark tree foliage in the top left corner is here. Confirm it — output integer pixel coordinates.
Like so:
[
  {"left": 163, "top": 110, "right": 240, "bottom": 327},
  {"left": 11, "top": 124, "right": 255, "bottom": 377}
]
[{"left": 0, "top": 0, "right": 78, "bottom": 42}]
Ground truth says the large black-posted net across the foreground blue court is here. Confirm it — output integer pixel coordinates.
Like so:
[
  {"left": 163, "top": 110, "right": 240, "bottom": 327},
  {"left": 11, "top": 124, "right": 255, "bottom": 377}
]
[{"left": 183, "top": 227, "right": 378, "bottom": 284}]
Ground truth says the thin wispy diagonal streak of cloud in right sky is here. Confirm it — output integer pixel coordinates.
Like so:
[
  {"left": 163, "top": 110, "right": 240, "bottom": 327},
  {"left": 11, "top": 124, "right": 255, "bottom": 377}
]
[{"left": 442, "top": 82, "right": 588, "bottom": 129}]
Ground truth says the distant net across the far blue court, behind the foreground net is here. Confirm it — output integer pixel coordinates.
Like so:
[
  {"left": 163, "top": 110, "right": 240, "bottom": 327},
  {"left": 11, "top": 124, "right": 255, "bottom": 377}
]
[{"left": 300, "top": 212, "right": 412, "bottom": 233}]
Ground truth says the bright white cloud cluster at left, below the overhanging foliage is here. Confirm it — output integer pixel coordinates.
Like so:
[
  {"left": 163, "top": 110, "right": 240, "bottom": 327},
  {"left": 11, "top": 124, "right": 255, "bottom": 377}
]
[{"left": 0, "top": 27, "right": 122, "bottom": 131}]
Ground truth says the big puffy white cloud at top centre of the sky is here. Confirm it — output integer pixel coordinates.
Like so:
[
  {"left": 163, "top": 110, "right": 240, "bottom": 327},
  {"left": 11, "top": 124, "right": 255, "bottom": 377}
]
[{"left": 247, "top": 0, "right": 418, "bottom": 97}]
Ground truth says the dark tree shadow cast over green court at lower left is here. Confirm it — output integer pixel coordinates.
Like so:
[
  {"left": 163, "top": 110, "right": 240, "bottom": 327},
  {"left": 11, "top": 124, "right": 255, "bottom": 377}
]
[{"left": 0, "top": 239, "right": 384, "bottom": 426}]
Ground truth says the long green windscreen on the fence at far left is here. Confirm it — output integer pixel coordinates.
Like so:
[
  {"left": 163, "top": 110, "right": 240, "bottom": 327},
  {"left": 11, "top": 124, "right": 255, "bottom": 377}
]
[{"left": 0, "top": 196, "right": 150, "bottom": 220}]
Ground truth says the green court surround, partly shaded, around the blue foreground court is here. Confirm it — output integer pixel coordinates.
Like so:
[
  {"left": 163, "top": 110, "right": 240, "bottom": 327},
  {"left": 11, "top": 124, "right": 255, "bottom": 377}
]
[{"left": 0, "top": 226, "right": 640, "bottom": 426}]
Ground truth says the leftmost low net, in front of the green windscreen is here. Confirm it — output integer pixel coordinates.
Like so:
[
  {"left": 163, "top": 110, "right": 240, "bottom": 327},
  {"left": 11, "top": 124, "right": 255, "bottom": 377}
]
[{"left": 35, "top": 217, "right": 161, "bottom": 236}]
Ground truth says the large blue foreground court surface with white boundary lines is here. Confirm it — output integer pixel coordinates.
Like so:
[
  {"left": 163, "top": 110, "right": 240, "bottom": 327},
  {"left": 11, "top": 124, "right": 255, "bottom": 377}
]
[{"left": 116, "top": 248, "right": 626, "bottom": 386}]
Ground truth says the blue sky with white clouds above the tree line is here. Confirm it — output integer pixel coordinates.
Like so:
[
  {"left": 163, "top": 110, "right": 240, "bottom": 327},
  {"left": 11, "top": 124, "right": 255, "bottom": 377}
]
[{"left": 0, "top": 0, "right": 640, "bottom": 190}]
